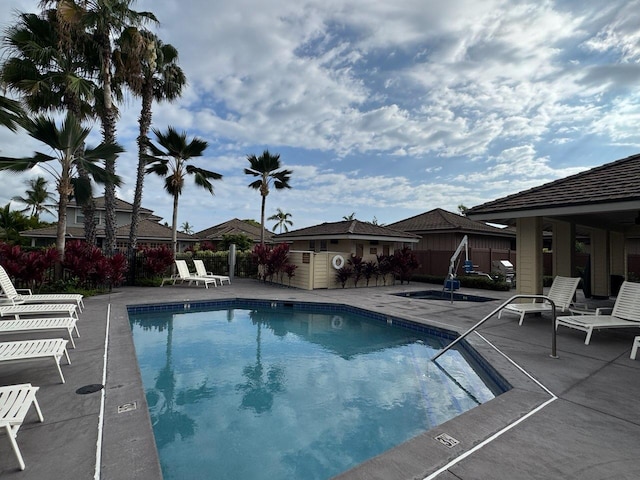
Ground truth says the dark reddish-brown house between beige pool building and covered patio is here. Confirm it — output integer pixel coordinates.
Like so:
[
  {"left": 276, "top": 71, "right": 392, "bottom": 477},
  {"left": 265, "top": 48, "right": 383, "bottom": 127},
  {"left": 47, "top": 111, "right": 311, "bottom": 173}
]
[{"left": 388, "top": 208, "right": 516, "bottom": 275}]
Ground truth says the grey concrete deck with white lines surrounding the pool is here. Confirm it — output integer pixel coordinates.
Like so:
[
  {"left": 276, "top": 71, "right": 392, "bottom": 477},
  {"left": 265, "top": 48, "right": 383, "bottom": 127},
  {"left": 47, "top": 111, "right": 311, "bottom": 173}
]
[{"left": 0, "top": 279, "right": 640, "bottom": 480}]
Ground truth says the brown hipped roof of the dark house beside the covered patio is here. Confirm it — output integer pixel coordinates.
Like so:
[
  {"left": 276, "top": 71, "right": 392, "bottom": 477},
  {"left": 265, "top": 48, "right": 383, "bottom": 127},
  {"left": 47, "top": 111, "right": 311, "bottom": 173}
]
[{"left": 387, "top": 208, "right": 515, "bottom": 236}]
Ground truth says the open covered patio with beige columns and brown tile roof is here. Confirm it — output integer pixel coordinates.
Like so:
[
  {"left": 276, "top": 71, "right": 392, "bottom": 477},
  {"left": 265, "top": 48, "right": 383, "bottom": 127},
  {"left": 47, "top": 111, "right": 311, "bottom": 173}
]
[{"left": 467, "top": 155, "right": 640, "bottom": 298}]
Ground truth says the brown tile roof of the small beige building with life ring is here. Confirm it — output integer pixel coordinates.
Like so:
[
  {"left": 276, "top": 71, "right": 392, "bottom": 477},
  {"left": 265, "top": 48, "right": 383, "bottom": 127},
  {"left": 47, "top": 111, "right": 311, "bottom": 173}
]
[{"left": 274, "top": 220, "right": 420, "bottom": 241}]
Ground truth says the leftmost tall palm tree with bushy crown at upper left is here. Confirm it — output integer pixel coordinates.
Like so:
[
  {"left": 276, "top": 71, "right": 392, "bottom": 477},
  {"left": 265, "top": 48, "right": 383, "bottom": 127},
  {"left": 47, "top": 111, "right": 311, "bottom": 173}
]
[{"left": 0, "top": 9, "right": 97, "bottom": 245}]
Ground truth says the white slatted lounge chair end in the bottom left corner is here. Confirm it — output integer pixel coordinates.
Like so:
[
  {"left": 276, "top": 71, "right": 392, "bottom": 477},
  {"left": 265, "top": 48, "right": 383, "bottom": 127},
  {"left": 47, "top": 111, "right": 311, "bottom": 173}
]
[{"left": 0, "top": 383, "right": 44, "bottom": 470}]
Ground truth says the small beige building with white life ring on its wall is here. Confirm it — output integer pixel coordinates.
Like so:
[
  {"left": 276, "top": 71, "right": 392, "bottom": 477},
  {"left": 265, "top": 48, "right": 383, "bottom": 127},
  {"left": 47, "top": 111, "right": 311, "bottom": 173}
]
[{"left": 273, "top": 220, "right": 420, "bottom": 290}]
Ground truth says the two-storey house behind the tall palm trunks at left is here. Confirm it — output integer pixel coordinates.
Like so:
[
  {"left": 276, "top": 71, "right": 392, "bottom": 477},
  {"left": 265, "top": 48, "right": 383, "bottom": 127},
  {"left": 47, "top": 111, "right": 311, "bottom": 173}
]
[{"left": 20, "top": 197, "right": 198, "bottom": 252}]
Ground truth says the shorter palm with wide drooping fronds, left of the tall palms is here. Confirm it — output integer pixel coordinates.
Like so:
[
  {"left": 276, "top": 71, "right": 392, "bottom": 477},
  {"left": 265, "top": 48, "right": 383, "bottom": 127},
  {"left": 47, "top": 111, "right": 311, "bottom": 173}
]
[{"left": 0, "top": 113, "right": 123, "bottom": 261}]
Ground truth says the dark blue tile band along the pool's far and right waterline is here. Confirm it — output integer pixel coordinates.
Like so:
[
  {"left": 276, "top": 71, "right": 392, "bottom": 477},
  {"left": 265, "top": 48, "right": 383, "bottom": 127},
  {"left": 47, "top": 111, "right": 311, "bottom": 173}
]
[{"left": 127, "top": 298, "right": 512, "bottom": 393}]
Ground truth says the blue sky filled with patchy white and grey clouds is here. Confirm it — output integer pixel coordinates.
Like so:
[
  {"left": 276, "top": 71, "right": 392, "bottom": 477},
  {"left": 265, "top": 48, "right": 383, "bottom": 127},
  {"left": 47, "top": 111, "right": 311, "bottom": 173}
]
[{"left": 0, "top": 0, "right": 640, "bottom": 231}]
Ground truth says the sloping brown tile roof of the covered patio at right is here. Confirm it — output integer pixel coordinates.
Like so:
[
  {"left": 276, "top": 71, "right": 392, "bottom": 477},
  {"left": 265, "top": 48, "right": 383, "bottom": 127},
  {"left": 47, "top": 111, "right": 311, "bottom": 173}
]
[{"left": 467, "top": 154, "right": 640, "bottom": 215}]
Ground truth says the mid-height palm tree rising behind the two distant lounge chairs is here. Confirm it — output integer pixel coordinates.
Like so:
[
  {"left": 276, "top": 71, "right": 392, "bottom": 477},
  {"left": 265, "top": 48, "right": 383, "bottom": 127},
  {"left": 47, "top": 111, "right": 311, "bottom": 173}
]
[{"left": 146, "top": 127, "right": 222, "bottom": 255}]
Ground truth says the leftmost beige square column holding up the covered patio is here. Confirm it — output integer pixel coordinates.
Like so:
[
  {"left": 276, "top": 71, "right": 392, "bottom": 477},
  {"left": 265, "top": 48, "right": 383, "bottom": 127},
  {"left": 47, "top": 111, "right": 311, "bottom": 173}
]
[{"left": 516, "top": 217, "right": 542, "bottom": 295}]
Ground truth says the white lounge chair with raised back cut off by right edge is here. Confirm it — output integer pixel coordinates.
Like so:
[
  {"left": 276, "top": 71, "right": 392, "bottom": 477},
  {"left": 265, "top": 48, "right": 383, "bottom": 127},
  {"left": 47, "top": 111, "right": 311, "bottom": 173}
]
[{"left": 556, "top": 282, "right": 640, "bottom": 345}]
